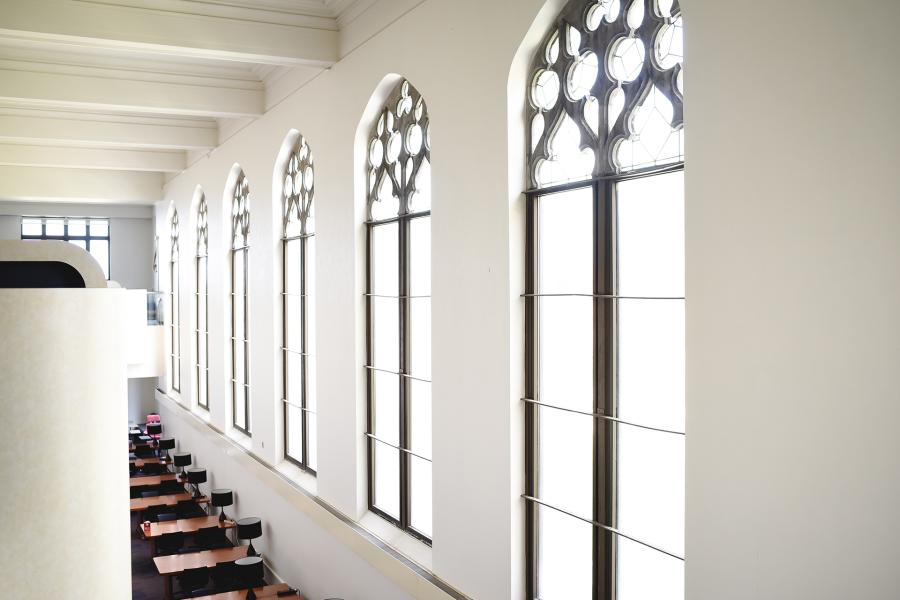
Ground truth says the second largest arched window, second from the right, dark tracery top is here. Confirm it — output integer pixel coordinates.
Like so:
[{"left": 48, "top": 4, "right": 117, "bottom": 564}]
[{"left": 366, "top": 81, "right": 431, "bottom": 541}]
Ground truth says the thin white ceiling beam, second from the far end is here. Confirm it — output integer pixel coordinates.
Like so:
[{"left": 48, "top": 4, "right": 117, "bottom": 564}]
[{"left": 0, "top": 144, "right": 186, "bottom": 173}]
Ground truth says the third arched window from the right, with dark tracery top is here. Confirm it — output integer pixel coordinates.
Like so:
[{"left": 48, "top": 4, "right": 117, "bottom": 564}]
[{"left": 282, "top": 136, "right": 316, "bottom": 473}]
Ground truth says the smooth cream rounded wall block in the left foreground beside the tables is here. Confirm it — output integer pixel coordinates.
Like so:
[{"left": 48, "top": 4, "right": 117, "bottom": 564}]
[{"left": 0, "top": 289, "right": 131, "bottom": 600}]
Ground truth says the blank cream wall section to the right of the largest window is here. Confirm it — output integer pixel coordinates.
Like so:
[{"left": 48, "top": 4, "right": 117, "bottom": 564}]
[{"left": 684, "top": 0, "right": 900, "bottom": 600}]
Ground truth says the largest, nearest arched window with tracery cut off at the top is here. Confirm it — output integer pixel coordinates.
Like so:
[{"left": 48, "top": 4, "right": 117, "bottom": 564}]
[{"left": 524, "top": 0, "right": 685, "bottom": 600}]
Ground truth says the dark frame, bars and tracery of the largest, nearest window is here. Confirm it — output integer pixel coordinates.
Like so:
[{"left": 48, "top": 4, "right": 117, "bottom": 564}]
[{"left": 522, "top": 0, "right": 684, "bottom": 600}]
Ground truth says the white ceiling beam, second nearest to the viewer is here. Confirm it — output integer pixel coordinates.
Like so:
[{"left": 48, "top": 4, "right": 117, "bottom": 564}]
[{"left": 0, "top": 61, "right": 265, "bottom": 118}]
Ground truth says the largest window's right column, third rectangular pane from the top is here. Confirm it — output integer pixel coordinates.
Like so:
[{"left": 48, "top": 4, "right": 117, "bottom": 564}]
[{"left": 617, "top": 425, "right": 684, "bottom": 555}]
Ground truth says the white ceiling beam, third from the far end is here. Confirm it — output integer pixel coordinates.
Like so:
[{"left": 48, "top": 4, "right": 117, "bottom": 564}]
[{"left": 0, "top": 108, "right": 219, "bottom": 150}]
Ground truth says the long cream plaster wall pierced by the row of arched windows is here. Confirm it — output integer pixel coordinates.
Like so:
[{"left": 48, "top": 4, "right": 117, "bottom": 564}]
[{"left": 156, "top": 0, "right": 900, "bottom": 600}]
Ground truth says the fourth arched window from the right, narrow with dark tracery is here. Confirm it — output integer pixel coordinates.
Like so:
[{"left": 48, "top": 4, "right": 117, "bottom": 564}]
[{"left": 231, "top": 171, "right": 250, "bottom": 435}]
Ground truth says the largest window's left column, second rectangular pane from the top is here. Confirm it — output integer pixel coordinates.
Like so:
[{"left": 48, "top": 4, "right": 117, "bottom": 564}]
[{"left": 536, "top": 296, "right": 594, "bottom": 411}]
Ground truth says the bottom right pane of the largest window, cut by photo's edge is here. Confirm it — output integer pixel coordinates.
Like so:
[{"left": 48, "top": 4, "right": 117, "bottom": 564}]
[{"left": 616, "top": 537, "right": 684, "bottom": 600}]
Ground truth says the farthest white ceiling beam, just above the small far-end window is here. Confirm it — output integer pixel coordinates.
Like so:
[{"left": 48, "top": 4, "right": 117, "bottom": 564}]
[{"left": 0, "top": 166, "right": 163, "bottom": 204}]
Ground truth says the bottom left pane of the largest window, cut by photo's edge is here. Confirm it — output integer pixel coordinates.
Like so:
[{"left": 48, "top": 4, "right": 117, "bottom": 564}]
[{"left": 535, "top": 505, "right": 596, "bottom": 600}]
